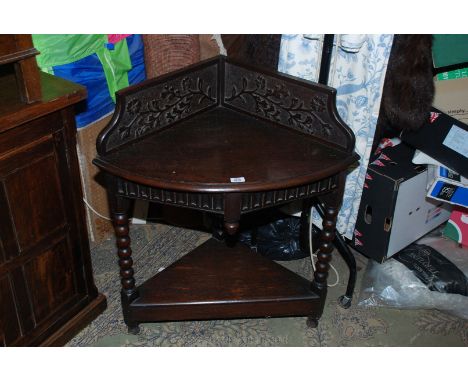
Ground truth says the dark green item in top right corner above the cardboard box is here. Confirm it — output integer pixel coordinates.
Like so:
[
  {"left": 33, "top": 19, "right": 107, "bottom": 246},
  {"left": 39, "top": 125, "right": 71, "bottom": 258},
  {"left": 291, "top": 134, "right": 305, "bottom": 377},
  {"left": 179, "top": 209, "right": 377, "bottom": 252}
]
[{"left": 432, "top": 34, "right": 468, "bottom": 68}]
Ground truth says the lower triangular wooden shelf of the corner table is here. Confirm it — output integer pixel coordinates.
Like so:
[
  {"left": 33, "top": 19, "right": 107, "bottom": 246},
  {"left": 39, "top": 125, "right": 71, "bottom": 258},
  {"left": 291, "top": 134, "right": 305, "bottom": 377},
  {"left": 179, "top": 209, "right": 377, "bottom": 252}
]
[{"left": 129, "top": 239, "right": 322, "bottom": 322}]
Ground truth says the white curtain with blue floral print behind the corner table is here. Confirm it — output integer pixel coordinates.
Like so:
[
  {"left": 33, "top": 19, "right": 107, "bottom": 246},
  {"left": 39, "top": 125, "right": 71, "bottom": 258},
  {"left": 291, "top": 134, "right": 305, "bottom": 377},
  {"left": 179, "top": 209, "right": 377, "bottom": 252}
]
[{"left": 278, "top": 34, "right": 393, "bottom": 239}]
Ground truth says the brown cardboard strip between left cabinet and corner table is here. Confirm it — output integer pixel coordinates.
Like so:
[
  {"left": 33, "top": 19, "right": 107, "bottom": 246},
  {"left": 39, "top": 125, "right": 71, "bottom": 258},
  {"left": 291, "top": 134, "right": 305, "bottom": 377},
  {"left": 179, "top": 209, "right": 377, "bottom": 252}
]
[{"left": 76, "top": 115, "right": 114, "bottom": 244}]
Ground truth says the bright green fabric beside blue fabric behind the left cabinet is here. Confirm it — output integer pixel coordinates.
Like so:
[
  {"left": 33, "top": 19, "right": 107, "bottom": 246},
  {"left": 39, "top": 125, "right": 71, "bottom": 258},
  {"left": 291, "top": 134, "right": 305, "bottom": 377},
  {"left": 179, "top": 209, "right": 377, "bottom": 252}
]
[{"left": 32, "top": 34, "right": 132, "bottom": 102}]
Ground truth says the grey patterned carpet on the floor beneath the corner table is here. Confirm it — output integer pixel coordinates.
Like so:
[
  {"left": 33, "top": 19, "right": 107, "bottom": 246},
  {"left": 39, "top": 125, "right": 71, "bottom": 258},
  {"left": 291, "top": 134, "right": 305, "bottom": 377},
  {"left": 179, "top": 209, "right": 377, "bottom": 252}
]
[{"left": 67, "top": 224, "right": 468, "bottom": 347}]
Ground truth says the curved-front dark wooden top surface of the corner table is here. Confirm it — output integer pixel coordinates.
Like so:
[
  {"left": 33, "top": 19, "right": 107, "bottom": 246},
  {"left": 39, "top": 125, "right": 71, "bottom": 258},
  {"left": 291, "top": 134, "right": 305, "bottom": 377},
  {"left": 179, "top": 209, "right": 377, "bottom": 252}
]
[{"left": 94, "top": 108, "right": 356, "bottom": 192}]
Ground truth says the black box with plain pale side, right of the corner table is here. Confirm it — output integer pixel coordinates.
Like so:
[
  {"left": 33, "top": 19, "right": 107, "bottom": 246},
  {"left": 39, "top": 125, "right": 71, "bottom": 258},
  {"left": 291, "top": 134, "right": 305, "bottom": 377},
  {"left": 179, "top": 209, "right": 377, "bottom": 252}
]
[{"left": 351, "top": 143, "right": 451, "bottom": 262}]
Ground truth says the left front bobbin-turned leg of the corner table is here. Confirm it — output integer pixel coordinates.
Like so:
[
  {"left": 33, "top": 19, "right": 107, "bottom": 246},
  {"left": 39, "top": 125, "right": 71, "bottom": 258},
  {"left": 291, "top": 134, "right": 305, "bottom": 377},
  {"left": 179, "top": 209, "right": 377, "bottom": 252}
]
[{"left": 111, "top": 191, "right": 140, "bottom": 334}]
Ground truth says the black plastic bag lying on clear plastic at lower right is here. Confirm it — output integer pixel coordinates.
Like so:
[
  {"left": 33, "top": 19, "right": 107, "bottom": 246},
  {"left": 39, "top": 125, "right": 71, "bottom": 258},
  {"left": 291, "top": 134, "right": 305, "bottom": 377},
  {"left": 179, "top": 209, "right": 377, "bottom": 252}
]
[{"left": 393, "top": 244, "right": 468, "bottom": 296}]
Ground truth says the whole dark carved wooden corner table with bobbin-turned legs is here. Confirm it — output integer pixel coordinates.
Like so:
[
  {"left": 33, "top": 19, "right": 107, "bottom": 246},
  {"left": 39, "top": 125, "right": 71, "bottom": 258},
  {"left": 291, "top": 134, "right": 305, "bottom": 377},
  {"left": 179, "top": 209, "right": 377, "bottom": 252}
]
[{"left": 94, "top": 57, "right": 358, "bottom": 332}]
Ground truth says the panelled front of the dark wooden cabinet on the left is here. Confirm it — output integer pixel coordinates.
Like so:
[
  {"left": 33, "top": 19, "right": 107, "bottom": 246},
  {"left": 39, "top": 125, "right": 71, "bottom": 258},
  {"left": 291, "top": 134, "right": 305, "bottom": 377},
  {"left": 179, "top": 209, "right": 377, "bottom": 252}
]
[{"left": 0, "top": 112, "right": 86, "bottom": 346}]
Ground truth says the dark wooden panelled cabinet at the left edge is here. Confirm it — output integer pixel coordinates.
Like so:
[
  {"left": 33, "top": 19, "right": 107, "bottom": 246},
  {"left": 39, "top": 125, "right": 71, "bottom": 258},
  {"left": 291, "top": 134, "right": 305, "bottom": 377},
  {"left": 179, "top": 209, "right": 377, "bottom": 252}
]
[{"left": 0, "top": 36, "right": 105, "bottom": 346}]
